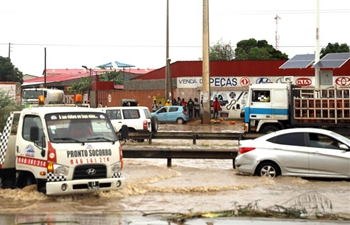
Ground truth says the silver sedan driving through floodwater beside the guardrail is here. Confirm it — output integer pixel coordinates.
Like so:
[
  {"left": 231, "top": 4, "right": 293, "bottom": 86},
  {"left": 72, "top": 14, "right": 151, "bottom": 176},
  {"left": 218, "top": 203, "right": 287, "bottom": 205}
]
[{"left": 235, "top": 128, "right": 350, "bottom": 179}]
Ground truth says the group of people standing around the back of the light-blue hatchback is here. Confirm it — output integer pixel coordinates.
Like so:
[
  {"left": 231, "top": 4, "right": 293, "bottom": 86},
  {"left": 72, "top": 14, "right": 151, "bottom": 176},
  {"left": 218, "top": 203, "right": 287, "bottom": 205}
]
[{"left": 152, "top": 97, "right": 200, "bottom": 119}]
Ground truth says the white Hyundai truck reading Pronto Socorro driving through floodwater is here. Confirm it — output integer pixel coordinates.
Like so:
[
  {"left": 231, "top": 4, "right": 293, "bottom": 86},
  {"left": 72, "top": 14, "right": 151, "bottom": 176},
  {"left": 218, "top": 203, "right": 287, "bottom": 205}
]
[{"left": 0, "top": 98, "right": 127, "bottom": 195}]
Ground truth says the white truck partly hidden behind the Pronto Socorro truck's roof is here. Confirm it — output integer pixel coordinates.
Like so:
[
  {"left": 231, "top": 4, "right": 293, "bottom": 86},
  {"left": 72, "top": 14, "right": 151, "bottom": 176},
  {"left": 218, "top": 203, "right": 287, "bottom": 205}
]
[{"left": 22, "top": 88, "right": 64, "bottom": 108}]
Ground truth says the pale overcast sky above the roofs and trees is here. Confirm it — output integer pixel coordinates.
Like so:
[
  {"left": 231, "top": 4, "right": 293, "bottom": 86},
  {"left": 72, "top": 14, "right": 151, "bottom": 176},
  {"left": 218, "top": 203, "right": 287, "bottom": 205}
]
[{"left": 0, "top": 0, "right": 350, "bottom": 75}]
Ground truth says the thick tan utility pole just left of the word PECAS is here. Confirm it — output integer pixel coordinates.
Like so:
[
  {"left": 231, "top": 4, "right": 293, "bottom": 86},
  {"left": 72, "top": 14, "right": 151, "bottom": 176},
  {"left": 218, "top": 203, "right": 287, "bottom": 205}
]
[{"left": 202, "top": 0, "right": 211, "bottom": 124}]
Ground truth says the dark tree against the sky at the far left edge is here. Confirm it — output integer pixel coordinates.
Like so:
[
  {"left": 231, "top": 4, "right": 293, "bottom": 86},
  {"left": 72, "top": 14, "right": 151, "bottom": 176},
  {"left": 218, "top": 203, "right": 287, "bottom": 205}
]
[{"left": 0, "top": 56, "right": 23, "bottom": 84}]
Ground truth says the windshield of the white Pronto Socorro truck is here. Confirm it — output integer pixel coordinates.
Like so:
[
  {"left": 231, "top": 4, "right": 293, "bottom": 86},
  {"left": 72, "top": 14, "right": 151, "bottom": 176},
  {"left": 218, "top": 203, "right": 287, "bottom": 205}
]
[{"left": 45, "top": 112, "right": 118, "bottom": 143}]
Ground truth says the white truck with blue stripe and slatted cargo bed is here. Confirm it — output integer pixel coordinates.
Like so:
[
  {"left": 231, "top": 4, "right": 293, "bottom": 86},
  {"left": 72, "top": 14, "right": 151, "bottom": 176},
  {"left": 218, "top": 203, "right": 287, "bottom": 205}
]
[{"left": 241, "top": 83, "right": 350, "bottom": 133}]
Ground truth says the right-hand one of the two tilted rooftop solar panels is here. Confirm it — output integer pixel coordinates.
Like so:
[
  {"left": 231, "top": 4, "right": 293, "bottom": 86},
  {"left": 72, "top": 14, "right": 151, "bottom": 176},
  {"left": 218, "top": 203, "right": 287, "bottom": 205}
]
[{"left": 312, "top": 52, "right": 350, "bottom": 68}]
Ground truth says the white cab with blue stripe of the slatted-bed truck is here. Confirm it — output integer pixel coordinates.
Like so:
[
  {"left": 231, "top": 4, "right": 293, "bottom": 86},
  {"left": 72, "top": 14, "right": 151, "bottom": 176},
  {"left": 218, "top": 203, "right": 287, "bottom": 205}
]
[{"left": 242, "top": 83, "right": 289, "bottom": 133}]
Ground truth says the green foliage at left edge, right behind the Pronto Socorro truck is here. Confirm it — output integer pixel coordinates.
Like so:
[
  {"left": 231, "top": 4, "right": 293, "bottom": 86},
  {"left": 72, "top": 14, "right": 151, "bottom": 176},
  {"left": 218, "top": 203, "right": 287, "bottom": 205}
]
[{"left": 0, "top": 90, "right": 22, "bottom": 132}]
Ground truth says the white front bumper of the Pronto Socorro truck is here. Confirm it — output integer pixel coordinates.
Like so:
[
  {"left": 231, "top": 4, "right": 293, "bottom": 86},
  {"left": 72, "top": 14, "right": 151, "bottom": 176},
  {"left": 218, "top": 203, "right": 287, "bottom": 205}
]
[{"left": 46, "top": 178, "right": 124, "bottom": 195}]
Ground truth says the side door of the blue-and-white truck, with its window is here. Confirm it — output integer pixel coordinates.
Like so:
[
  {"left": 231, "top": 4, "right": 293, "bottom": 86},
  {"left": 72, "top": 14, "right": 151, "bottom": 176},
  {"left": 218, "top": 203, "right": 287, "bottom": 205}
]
[{"left": 250, "top": 89, "right": 273, "bottom": 119}]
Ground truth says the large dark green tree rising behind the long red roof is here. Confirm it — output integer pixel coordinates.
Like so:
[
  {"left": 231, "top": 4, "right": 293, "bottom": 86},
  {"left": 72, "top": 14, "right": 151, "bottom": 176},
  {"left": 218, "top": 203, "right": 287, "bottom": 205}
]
[{"left": 235, "top": 38, "right": 288, "bottom": 60}]
